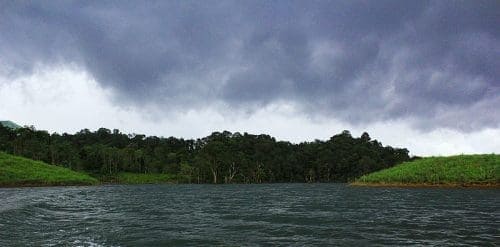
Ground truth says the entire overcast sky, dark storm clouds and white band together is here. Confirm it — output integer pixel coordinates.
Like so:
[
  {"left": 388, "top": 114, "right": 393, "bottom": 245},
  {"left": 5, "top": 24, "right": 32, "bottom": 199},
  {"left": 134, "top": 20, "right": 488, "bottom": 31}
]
[{"left": 0, "top": 0, "right": 500, "bottom": 155}]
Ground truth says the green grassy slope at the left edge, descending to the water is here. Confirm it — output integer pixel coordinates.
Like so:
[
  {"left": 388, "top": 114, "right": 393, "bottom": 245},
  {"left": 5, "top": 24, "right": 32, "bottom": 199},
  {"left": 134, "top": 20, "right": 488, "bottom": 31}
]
[{"left": 0, "top": 152, "right": 98, "bottom": 187}]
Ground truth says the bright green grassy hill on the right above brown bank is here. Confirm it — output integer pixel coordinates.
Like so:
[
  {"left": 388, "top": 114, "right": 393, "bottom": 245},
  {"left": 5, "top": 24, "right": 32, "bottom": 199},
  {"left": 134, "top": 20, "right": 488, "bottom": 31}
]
[{"left": 353, "top": 154, "right": 500, "bottom": 186}]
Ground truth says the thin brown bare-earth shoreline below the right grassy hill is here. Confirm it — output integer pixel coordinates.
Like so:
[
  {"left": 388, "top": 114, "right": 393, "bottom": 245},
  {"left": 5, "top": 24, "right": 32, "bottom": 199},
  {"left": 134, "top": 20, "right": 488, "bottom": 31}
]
[{"left": 349, "top": 182, "right": 500, "bottom": 189}]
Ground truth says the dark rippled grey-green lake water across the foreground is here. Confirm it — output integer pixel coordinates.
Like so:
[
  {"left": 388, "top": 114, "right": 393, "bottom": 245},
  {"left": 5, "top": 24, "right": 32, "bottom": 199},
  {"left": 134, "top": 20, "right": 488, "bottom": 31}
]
[{"left": 0, "top": 184, "right": 500, "bottom": 246}]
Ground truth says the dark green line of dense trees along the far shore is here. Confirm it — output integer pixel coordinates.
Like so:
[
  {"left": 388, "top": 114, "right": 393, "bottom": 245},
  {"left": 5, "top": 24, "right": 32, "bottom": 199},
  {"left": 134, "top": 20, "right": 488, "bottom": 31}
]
[{"left": 0, "top": 125, "right": 409, "bottom": 183}]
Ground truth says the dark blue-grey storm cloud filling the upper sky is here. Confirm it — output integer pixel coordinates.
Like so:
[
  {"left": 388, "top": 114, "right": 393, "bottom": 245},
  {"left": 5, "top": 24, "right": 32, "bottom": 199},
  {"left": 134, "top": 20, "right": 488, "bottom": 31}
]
[{"left": 0, "top": 1, "right": 500, "bottom": 130}]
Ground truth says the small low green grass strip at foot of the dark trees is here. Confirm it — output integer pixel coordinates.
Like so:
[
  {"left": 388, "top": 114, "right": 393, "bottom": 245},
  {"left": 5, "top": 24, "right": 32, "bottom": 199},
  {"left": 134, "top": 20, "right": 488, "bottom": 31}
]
[{"left": 113, "top": 172, "right": 184, "bottom": 184}]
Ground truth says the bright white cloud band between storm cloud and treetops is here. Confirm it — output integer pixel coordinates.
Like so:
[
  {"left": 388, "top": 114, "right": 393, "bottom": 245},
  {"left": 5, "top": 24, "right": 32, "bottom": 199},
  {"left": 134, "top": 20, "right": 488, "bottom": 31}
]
[{"left": 0, "top": 67, "right": 500, "bottom": 155}]
